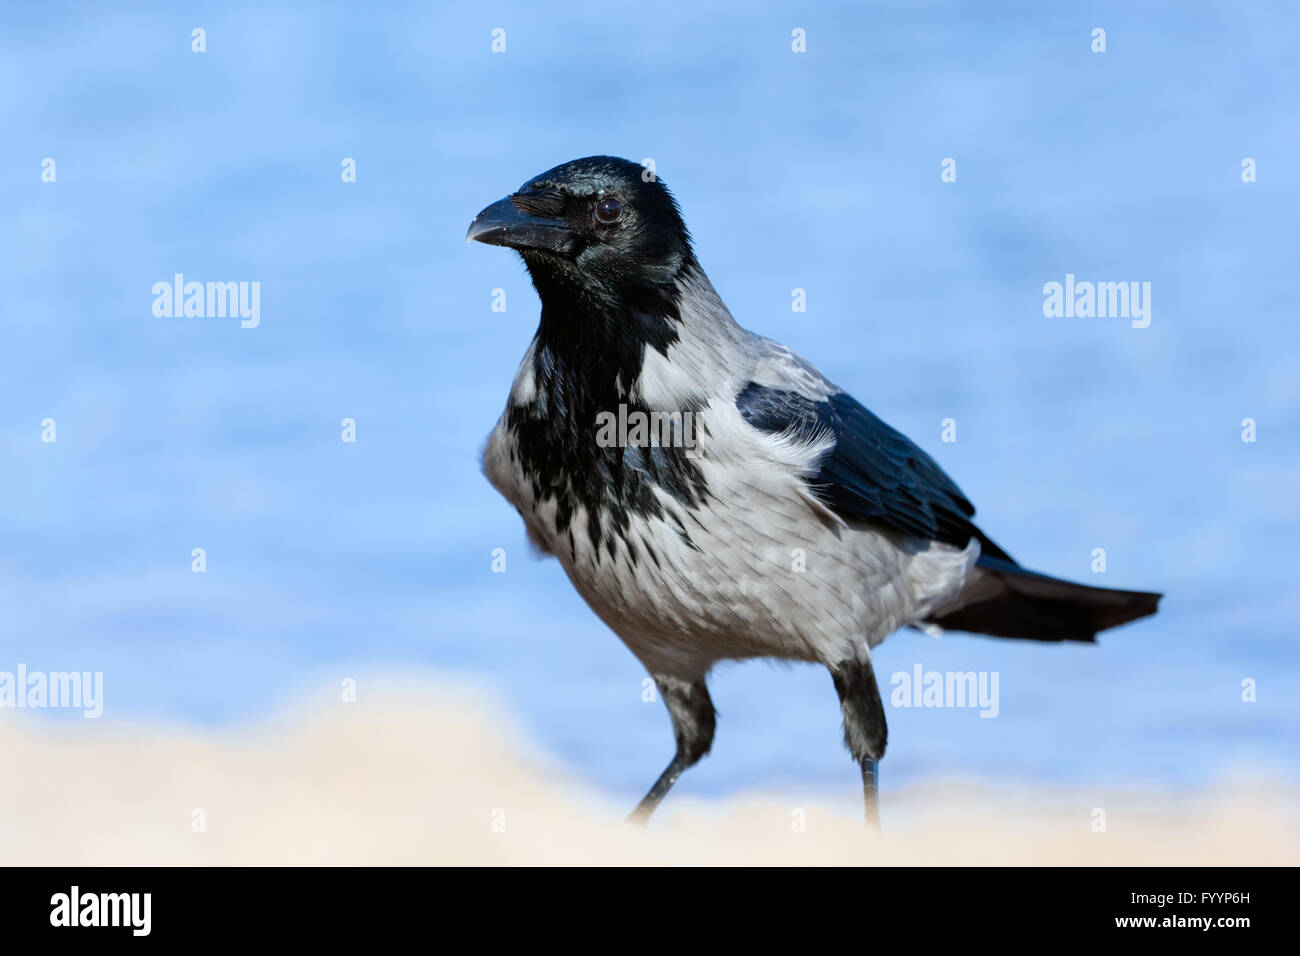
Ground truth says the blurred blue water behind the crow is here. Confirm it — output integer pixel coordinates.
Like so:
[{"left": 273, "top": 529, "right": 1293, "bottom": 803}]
[{"left": 0, "top": 3, "right": 1300, "bottom": 797}]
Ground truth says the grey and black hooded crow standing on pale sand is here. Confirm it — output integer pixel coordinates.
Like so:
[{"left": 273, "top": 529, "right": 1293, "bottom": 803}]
[{"left": 465, "top": 156, "right": 1161, "bottom": 822}]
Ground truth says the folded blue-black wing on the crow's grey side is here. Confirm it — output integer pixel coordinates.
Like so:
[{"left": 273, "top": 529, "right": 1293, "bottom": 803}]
[{"left": 736, "top": 382, "right": 1014, "bottom": 563}]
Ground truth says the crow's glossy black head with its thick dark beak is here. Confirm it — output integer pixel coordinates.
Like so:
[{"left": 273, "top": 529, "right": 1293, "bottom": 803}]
[{"left": 465, "top": 156, "right": 693, "bottom": 304}]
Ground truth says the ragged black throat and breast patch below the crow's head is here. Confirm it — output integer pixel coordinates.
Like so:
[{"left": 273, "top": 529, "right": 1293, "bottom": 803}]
[{"left": 507, "top": 254, "right": 709, "bottom": 564}]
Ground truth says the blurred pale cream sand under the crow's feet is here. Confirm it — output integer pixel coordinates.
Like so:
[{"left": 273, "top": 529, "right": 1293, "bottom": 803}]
[{"left": 0, "top": 684, "right": 1300, "bottom": 865}]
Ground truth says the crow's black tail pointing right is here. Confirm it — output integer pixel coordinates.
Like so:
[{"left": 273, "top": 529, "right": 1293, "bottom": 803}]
[{"left": 931, "top": 554, "right": 1162, "bottom": 641}]
